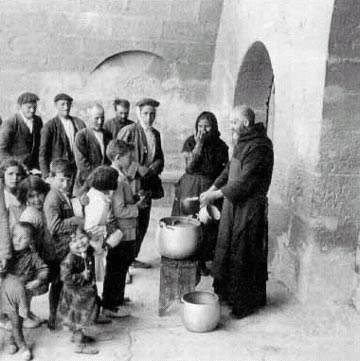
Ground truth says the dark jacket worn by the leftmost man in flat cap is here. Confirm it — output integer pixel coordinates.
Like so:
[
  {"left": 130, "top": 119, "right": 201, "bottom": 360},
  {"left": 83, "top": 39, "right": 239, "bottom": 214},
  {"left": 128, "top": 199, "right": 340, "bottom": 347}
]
[{"left": 0, "top": 113, "right": 43, "bottom": 169}]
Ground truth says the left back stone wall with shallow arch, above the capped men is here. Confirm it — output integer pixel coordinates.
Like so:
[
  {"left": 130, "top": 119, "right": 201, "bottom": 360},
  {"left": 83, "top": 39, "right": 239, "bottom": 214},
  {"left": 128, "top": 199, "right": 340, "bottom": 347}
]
[{"left": 0, "top": 0, "right": 222, "bottom": 173}]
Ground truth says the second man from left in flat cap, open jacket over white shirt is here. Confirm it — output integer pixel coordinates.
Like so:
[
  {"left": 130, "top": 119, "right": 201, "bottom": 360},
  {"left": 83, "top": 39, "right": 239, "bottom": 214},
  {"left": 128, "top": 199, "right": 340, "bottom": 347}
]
[{"left": 39, "top": 93, "right": 86, "bottom": 179}]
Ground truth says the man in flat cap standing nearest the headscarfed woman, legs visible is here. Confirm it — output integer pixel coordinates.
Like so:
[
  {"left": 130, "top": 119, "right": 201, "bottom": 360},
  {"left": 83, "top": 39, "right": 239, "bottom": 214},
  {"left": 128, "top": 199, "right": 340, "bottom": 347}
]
[{"left": 118, "top": 98, "right": 164, "bottom": 268}]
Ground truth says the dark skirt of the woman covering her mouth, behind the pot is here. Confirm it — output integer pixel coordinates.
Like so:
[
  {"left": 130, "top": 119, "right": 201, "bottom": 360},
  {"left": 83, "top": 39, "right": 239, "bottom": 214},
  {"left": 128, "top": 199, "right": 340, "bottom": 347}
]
[{"left": 171, "top": 173, "right": 222, "bottom": 261}]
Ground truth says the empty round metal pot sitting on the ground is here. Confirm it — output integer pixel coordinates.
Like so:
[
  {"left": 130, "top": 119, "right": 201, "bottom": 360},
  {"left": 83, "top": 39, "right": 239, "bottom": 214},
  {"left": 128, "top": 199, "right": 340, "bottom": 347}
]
[{"left": 182, "top": 291, "right": 220, "bottom": 332}]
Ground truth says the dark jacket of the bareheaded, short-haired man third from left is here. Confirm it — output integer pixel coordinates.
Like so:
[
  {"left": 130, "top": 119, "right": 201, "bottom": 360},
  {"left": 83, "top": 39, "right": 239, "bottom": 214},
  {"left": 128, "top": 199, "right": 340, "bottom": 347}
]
[{"left": 74, "top": 128, "right": 111, "bottom": 195}]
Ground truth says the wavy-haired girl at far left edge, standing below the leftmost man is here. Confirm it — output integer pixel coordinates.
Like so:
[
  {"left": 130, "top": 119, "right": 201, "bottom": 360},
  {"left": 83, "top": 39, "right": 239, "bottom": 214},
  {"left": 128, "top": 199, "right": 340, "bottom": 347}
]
[{"left": 0, "top": 158, "right": 26, "bottom": 229}]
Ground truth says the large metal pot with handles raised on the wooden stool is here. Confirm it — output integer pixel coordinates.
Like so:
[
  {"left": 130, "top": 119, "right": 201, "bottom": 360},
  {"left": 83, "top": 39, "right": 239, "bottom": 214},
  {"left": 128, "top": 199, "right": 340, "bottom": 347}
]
[{"left": 157, "top": 217, "right": 200, "bottom": 259}]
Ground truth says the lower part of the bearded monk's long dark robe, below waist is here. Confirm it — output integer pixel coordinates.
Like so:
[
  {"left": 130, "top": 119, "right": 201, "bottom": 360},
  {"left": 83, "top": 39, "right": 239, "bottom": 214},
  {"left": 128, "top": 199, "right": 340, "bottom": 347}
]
[{"left": 212, "top": 199, "right": 268, "bottom": 314}]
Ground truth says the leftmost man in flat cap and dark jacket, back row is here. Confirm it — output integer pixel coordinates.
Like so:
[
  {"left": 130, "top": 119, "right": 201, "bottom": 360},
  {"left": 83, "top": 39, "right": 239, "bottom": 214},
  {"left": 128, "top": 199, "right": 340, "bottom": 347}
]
[{"left": 0, "top": 93, "right": 43, "bottom": 170}]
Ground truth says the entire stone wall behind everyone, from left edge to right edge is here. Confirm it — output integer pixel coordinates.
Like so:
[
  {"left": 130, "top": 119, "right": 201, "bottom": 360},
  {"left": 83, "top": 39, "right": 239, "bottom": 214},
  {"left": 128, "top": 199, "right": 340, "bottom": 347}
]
[{"left": 0, "top": 0, "right": 360, "bottom": 304}]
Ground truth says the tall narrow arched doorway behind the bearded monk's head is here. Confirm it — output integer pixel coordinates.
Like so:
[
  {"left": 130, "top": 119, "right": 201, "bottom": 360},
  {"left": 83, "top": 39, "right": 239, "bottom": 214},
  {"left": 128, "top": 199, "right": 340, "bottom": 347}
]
[{"left": 234, "top": 41, "right": 275, "bottom": 138}]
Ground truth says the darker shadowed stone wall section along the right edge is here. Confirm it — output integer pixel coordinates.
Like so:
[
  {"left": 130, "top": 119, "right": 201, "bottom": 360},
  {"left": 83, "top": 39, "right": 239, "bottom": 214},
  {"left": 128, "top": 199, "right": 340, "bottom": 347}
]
[{"left": 320, "top": 0, "right": 360, "bottom": 309}]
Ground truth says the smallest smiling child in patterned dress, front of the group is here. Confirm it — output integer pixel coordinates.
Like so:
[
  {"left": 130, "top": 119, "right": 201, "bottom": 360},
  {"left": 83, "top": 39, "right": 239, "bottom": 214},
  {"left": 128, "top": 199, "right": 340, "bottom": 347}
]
[{"left": 57, "top": 227, "right": 100, "bottom": 354}]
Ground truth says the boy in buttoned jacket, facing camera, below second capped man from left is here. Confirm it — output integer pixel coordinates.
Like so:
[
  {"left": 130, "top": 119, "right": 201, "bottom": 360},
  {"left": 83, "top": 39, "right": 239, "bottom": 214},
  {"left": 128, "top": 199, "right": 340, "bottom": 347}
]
[{"left": 44, "top": 158, "right": 84, "bottom": 329}]
